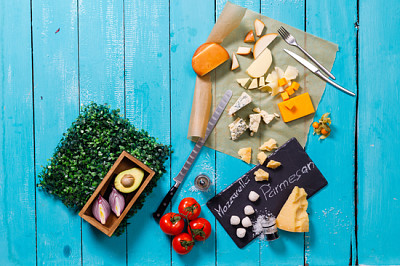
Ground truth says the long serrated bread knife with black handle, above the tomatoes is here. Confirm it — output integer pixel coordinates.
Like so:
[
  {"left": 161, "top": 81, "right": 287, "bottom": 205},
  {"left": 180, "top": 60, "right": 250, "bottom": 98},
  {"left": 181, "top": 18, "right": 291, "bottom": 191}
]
[{"left": 153, "top": 90, "right": 232, "bottom": 222}]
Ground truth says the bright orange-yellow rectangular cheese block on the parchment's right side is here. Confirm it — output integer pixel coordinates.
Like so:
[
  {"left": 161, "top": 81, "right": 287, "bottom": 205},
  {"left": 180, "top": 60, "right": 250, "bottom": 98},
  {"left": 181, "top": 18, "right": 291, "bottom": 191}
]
[{"left": 278, "top": 92, "right": 315, "bottom": 122}]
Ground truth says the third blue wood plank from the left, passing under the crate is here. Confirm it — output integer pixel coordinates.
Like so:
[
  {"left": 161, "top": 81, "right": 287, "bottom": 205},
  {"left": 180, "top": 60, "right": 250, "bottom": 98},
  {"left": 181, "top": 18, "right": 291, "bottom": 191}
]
[{"left": 78, "top": 0, "right": 126, "bottom": 265}]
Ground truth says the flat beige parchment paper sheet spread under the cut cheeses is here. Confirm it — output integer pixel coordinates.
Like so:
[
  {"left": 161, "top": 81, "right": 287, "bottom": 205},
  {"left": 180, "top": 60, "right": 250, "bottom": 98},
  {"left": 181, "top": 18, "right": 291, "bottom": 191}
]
[{"left": 188, "top": 2, "right": 338, "bottom": 164}]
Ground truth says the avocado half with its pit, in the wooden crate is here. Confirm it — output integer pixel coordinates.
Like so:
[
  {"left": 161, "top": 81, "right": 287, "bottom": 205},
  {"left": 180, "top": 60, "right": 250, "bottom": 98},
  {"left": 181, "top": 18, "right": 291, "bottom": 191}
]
[{"left": 114, "top": 168, "right": 144, "bottom": 193}]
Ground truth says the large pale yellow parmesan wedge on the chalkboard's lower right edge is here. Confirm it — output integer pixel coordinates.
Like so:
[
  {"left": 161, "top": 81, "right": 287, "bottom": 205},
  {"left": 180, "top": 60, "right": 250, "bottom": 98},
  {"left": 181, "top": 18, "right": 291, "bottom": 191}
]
[{"left": 276, "top": 186, "right": 309, "bottom": 232}]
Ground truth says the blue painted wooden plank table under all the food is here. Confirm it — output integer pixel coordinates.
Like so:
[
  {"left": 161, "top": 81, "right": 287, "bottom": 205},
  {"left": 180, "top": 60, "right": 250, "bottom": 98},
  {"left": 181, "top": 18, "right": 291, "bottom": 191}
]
[{"left": 0, "top": 0, "right": 400, "bottom": 265}]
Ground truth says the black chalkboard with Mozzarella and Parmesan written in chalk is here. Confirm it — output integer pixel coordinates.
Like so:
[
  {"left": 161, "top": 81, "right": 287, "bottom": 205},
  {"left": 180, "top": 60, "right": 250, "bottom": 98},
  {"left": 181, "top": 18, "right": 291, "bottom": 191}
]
[{"left": 207, "top": 138, "right": 328, "bottom": 248}]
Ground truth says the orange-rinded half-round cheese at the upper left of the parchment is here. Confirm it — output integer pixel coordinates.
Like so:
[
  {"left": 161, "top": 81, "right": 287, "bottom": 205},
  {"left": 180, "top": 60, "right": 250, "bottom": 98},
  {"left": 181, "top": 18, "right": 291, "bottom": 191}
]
[{"left": 192, "top": 42, "right": 229, "bottom": 76}]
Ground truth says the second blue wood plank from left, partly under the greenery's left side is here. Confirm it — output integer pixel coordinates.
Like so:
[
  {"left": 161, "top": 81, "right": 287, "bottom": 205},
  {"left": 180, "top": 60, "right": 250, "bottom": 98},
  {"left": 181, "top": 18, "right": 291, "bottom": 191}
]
[{"left": 32, "top": 1, "right": 81, "bottom": 265}]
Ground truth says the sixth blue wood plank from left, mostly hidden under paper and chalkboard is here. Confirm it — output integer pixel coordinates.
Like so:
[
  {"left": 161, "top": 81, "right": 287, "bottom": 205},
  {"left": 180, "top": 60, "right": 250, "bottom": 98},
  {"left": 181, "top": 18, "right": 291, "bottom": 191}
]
[{"left": 216, "top": 0, "right": 260, "bottom": 265}]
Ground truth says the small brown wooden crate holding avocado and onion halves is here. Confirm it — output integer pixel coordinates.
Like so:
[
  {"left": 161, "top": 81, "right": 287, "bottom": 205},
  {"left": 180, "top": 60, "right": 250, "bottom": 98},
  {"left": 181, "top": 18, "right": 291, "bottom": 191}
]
[{"left": 79, "top": 151, "right": 155, "bottom": 236}]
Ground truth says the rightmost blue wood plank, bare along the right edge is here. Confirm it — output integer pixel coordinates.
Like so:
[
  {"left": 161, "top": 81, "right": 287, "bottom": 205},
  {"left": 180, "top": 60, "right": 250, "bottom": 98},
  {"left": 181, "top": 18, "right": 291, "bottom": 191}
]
[{"left": 358, "top": 0, "right": 400, "bottom": 265}]
